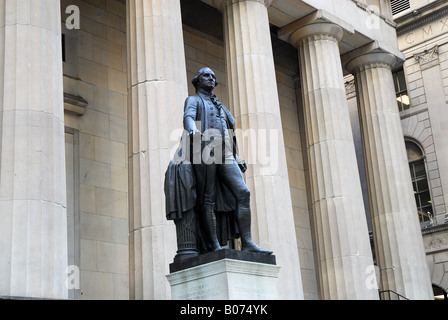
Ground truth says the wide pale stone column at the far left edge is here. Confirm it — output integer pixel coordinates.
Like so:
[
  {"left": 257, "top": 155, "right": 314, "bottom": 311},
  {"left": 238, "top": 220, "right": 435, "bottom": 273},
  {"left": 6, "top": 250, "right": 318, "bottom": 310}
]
[{"left": 0, "top": 0, "right": 68, "bottom": 299}]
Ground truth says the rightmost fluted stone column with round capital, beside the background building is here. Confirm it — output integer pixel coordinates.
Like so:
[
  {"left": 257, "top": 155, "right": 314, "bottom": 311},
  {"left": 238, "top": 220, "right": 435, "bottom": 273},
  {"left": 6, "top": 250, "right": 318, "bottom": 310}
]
[{"left": 347, "top": 53, "right": 433, "bottom": 300}]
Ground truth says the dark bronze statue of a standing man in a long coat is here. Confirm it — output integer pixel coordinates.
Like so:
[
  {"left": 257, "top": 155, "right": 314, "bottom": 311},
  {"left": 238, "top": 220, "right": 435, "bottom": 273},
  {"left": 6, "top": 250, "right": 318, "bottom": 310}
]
[{"left": 165, "top": 68, "right": 272, "bottom": 255}]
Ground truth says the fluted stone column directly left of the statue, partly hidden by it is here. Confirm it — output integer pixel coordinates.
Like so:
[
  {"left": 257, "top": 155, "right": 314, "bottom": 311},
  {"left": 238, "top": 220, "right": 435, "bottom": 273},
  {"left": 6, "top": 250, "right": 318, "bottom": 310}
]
[{"left": 127, "top": 0, "right": 188, "bottom": 300}]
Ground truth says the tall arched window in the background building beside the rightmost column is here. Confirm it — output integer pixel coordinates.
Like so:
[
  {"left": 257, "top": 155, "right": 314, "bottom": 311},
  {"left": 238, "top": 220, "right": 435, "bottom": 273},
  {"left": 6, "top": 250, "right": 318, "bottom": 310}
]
[{"left": 406, "top": 141, "right": 434, "bottom": 223}]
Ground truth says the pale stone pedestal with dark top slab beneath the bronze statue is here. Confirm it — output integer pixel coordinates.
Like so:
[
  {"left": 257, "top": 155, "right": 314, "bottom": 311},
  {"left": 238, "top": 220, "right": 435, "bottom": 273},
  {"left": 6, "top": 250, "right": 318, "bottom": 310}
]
[{"left": 167, "top": 250, "right": 280, "bottom": 300}]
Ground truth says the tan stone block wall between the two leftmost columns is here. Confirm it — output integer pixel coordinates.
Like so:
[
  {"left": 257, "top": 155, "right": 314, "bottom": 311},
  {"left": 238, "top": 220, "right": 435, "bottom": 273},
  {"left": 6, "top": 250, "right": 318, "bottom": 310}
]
[{"left": 61, "top": 0, "right": 129, "bottom": 299}]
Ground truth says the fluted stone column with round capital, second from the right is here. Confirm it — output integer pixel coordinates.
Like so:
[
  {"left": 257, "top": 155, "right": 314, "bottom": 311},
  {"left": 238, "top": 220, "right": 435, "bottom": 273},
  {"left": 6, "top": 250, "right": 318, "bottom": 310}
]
[{"left": 290, "top": 23, "right": 378, "bottom": 300}]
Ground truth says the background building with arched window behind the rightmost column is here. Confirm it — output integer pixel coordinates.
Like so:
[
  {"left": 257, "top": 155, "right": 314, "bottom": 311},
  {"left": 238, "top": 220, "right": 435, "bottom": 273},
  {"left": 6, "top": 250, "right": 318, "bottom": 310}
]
[{"left": 391, "top": 0, "right": 448, "bottom": 299}]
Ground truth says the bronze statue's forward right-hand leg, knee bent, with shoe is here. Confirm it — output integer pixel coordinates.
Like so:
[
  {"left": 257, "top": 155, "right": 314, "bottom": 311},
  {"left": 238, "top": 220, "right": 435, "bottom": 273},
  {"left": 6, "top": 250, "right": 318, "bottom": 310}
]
[{"left": 218, "top": 161, "right": 273, "bottom": 255}]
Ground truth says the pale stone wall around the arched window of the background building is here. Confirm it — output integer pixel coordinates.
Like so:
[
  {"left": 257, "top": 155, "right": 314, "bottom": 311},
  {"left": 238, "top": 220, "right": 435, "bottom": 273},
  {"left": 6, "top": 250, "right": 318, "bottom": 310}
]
[{"left": 388, "top": 1, "right": 448, "bottom": 291}]
